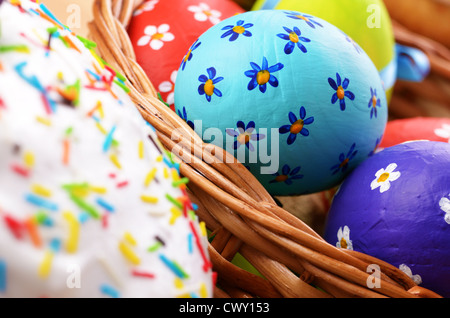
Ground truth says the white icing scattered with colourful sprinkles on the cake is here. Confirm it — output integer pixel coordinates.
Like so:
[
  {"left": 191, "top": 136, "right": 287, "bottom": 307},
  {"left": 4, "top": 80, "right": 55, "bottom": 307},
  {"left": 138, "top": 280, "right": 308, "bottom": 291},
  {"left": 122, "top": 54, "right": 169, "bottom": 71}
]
[{"left": 0, "top": 1, "right": 213, "bottom": 297}]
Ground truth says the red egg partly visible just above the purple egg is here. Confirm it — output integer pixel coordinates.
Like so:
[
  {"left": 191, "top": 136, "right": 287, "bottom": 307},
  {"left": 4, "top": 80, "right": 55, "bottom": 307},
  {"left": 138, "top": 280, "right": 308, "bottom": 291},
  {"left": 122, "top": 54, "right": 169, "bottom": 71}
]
[{"left": 379, "top": 117, "right": 450, "bottom": 148}]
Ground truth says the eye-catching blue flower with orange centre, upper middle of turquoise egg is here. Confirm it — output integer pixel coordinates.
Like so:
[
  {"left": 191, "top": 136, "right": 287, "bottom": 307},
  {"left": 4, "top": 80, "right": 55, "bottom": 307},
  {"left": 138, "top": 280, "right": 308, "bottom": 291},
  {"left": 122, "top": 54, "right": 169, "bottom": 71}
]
[{"left": 244, "top": 56, "right": 284, "bottom": 93}]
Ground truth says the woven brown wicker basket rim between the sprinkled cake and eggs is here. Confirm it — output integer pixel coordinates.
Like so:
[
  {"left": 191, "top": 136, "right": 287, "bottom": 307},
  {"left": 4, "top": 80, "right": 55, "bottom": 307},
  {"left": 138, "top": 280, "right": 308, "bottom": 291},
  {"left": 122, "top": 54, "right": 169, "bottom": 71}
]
[{"left": 89, "top": 0, "right": 439, "bottom": 298}]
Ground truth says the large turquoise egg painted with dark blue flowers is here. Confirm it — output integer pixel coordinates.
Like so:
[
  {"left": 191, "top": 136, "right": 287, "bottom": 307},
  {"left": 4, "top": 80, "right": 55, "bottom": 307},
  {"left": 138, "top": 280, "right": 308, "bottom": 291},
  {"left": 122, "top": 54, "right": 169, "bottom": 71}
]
[{"left": 175, "top": 10, "right": 387, "bottom": 195}]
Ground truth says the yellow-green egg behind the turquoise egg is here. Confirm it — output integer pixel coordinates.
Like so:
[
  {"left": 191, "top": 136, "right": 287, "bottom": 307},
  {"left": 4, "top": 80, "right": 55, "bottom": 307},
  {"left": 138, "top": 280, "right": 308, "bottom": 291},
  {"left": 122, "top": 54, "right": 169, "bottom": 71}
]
[{"left": 252, "top": 0, "right": 397, "bottom": 99}]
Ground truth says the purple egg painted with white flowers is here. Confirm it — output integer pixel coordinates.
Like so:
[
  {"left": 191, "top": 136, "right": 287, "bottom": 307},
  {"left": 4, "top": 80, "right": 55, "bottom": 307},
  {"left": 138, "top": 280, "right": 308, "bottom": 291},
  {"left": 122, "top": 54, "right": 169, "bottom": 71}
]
[{"left": 324, "top": 141, "right": 450, "bottom": 297}]
